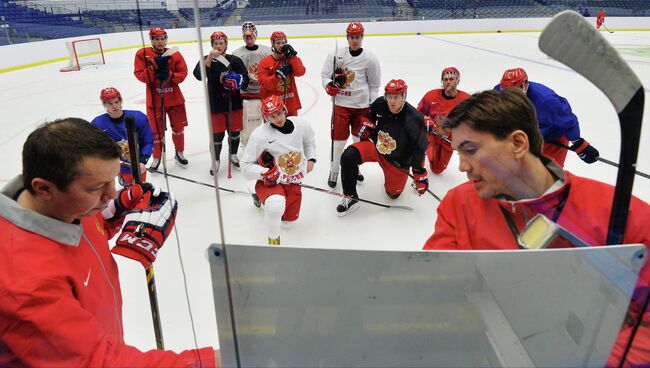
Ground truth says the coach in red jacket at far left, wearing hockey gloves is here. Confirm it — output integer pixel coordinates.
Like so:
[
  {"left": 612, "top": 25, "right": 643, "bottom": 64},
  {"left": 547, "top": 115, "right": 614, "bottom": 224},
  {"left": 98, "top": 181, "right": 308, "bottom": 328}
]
[{"left": 0, "top": 119, "right": 220, "bottom": 367}]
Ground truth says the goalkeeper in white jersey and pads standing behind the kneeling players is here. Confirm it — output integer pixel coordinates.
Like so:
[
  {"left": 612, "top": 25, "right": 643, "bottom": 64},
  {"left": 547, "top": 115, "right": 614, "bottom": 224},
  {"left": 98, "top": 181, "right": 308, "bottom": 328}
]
[{"left": 232, "top": 21, "right": 271, "bottom": 147}]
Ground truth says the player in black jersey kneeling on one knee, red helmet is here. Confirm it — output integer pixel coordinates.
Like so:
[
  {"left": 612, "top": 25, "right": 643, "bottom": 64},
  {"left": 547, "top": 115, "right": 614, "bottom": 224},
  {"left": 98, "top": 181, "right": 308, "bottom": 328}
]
[{"left": 336, "top": 79, "right": 429, "bottom": 216}]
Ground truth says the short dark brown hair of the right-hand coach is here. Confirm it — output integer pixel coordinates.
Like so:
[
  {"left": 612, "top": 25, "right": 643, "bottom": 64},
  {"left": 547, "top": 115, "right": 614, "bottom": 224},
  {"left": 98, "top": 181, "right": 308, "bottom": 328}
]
[{"left": 443, "top": 88, "right": 544, "bottom": 158}]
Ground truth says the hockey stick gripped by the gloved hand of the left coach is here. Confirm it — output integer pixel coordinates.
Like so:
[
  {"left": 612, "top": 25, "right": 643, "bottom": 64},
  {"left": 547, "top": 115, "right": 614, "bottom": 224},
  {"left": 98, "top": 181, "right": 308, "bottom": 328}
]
[{"left": 124, "top": 115, "right": 165, "bottom": 350}]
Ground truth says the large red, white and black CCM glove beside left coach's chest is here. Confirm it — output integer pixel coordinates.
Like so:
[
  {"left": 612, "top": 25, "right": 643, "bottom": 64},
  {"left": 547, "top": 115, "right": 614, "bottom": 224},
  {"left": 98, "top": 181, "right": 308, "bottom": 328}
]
[{"left": 111, "top": 192, "right": 178, "bottom": 269}]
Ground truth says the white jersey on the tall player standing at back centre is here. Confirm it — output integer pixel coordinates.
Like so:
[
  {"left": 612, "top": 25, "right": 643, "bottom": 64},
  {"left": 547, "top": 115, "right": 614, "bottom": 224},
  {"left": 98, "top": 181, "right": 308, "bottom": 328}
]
[{"left": 321, "top": 46, "right": 381, "bottom": 108}]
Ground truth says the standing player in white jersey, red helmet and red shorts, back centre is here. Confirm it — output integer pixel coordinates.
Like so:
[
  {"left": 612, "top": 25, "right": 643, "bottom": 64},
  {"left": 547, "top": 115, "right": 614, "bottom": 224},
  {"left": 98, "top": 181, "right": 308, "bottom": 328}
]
[{"left": 321, "top": 22, "right": 381, "bottom": 188}]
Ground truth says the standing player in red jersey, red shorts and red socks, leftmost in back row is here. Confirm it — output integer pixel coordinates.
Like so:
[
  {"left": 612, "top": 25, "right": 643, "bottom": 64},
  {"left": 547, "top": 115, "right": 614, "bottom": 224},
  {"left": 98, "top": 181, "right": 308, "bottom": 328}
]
[{"left": 133, "top": 27, "right": 188, "bottom": 170}]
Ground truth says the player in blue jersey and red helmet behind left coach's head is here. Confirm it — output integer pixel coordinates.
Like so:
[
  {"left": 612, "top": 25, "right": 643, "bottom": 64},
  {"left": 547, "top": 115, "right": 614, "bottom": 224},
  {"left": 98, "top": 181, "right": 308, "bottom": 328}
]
[{"left": 90, "top": 87, "right": 153, "bottom": 186}]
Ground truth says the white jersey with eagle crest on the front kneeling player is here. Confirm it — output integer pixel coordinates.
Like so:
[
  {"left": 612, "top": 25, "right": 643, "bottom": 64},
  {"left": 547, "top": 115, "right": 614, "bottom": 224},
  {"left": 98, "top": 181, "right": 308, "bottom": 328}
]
[{"left": 240, "top": 116, "right": 316, "bottom": 184}]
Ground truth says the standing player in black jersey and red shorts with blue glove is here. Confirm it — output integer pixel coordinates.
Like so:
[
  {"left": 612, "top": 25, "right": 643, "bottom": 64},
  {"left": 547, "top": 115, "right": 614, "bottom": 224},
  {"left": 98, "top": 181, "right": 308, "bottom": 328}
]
[{"left": 193, "top": 32, "right": 249, "bottom": 175}]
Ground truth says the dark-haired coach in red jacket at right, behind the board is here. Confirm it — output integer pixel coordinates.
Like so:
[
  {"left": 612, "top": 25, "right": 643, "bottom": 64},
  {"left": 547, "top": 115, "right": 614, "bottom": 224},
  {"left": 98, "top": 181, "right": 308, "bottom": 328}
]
[{"left": 424, "top": 90, "right": 650, "bottom": 366}]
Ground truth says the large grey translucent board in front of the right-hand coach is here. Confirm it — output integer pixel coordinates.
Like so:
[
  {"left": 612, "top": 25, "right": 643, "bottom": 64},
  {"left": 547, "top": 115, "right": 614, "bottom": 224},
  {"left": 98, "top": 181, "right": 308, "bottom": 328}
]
[{"left": 209, "top": 245, "right": 645, "bottom": 367}]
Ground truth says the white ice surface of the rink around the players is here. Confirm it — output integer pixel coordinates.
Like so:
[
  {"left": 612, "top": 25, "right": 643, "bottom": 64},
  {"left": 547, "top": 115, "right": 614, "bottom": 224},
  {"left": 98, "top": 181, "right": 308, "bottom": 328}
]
[{"left": 0, "top": 26, "right": 650, "bottom": 351}]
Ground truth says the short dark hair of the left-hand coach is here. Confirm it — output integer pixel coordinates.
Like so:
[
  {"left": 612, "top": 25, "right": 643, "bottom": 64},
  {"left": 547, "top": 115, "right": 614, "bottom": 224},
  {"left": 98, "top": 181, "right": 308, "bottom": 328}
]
[{"left": 23, "top": 118, "right": 120, "bottom": 193}]
